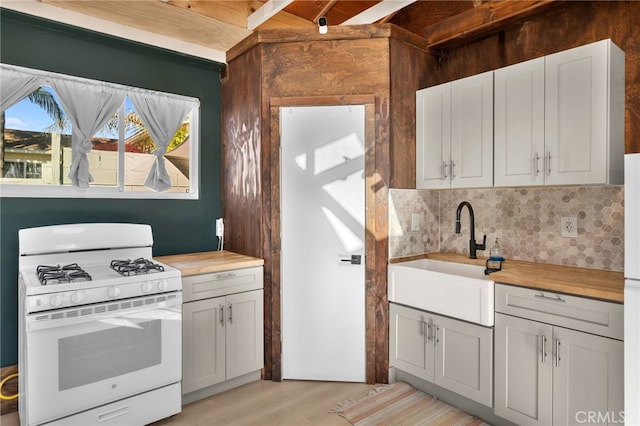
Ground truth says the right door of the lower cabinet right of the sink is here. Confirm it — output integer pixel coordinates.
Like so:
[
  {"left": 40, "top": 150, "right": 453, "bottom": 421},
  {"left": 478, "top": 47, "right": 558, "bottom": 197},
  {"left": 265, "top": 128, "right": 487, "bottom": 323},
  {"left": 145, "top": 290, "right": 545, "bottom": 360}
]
[{"left": 553, "top": 327, "right": 624, "bottom": 425}]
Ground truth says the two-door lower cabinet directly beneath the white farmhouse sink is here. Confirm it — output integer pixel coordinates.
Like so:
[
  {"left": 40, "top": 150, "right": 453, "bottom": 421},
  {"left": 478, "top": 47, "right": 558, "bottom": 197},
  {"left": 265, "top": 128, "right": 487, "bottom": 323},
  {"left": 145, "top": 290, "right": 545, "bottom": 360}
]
[{"left": 389, "top": 303, "right": 493, "bottom": 407}]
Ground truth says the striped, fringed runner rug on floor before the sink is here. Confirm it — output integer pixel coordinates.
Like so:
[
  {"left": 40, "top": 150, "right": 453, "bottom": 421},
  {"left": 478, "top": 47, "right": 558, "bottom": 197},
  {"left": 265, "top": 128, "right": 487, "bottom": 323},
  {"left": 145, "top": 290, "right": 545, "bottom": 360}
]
[{"left": 331, "top": 382, "right": 490, "bottom": 426}]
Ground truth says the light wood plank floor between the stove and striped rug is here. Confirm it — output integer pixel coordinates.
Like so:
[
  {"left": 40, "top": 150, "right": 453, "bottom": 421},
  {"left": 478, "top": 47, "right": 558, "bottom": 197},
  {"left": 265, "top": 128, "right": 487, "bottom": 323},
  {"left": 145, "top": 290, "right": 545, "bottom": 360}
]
[{"left": 0, "top": 380, "right": 375, "bottom": 426}]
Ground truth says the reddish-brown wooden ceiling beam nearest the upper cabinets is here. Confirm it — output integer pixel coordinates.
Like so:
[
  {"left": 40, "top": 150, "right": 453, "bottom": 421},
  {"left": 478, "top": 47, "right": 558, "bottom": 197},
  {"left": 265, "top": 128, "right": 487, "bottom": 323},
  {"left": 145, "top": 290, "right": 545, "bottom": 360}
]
[{"left": 423, "top": 0, "right": 558, "bottom": 49}]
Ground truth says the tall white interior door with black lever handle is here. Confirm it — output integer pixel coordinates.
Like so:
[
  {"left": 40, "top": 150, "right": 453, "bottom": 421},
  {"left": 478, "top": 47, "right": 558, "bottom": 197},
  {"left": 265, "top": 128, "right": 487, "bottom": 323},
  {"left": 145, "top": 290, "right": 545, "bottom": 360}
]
[{"left": 280, "top": 105, "right": 366, "bottom": 382}]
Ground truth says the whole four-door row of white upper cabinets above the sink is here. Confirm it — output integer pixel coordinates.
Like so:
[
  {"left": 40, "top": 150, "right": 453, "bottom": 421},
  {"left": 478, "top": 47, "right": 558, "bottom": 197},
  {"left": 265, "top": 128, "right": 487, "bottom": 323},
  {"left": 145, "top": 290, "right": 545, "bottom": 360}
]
[{"left": 416, "top": 40, "right": 625, "bottom": 189}]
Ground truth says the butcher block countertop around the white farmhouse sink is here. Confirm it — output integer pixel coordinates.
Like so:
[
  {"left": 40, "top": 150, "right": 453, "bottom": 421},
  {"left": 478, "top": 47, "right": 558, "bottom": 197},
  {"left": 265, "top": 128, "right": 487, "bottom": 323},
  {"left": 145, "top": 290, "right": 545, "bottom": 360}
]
[{"left": 390, "top": 252, "right": 624, "bottom": 302}]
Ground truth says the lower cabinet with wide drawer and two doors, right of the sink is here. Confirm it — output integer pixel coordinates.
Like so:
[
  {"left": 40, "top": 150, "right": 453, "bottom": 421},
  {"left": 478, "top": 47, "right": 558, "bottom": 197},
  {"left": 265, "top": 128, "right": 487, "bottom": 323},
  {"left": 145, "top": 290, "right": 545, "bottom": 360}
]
[{"left": 495, "top": 285, "right": 624, "bottom": 426}]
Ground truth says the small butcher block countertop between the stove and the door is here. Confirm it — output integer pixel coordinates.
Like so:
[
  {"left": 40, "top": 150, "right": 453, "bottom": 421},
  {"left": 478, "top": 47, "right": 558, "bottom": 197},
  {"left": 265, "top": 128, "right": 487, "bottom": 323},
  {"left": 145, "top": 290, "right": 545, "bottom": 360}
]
[{"left": 154, "top": 250, "right": 264, "bottom": 277}]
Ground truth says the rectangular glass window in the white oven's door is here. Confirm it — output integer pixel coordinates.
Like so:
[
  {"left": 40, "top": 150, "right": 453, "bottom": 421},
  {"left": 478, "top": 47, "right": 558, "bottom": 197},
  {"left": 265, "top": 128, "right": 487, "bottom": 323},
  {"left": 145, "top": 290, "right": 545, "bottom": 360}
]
[{"left": 58, "top": 319, "right": 162, "bottom": 391}]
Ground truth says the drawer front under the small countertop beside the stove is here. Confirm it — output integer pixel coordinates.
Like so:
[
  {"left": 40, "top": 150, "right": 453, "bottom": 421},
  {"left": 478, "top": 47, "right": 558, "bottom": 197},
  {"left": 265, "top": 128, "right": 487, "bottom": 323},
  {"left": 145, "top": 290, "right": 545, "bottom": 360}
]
[{"left": 182, "top": 266, "right": 263, "bottom": 302}]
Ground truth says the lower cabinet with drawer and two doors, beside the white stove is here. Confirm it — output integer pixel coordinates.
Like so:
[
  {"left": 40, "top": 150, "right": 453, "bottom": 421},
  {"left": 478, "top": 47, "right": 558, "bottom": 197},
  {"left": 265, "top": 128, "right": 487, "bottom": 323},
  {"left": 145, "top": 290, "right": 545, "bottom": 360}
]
[{"left": 182, "top": 267, "right": 264, "bottom": 394}]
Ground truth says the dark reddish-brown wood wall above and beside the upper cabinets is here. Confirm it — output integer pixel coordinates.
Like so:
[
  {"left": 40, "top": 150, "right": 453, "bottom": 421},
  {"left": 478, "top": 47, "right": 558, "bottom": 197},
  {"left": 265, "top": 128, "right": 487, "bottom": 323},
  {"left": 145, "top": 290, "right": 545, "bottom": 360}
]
[{"left": 428, "top": 1, "right": 640, "bottom": 153}]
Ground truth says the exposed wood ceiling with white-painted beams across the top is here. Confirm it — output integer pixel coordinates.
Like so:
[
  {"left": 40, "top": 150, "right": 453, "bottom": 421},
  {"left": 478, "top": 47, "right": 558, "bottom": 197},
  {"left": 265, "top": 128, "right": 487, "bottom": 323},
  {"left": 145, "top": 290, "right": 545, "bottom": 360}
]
[{"left": 12, "top": 0, "right": 553, "bottom": 61}]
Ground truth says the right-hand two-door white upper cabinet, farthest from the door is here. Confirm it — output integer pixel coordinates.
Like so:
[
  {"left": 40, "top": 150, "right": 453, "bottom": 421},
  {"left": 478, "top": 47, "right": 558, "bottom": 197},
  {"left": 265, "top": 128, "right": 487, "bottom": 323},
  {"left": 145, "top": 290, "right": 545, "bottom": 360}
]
[{"left": 494, "top": 40, "right": 625, "bottom": 186}]
